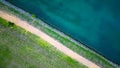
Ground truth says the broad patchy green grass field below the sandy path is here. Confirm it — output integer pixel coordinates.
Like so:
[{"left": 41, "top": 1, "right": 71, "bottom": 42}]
[{"left": 0, "top": 18, "right": 87, "bottom": 68}]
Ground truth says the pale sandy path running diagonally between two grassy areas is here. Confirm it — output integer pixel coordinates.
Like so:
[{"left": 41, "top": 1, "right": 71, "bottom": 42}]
[{"left": 0, "top": 11, "right": 100, "bottom": 68}]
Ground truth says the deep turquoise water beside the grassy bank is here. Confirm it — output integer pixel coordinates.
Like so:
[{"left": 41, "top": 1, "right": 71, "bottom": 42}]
[{"left": 6, "top": 0, "right": 120, "bottom": 65}]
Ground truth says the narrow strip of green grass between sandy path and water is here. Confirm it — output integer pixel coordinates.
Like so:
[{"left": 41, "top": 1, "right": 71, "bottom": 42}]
[{"left": 0, "top": 0, "right": 116, "bottom": 68}]
